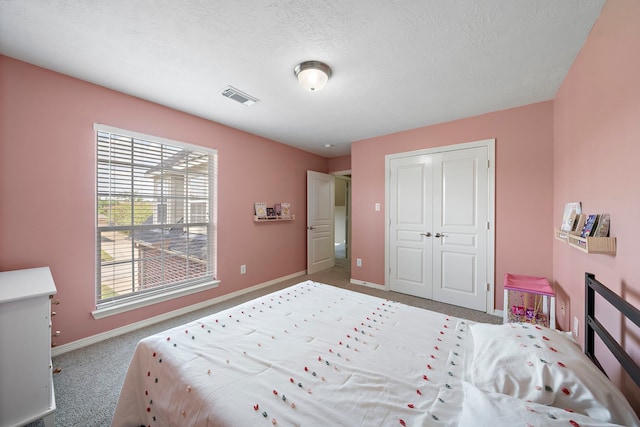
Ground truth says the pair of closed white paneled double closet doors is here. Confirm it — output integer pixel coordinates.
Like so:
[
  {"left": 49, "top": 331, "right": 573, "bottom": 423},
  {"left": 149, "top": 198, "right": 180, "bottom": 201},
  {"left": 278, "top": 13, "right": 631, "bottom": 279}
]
[{"left": 387, "top": 144, "right": 493, "bottom": 311}]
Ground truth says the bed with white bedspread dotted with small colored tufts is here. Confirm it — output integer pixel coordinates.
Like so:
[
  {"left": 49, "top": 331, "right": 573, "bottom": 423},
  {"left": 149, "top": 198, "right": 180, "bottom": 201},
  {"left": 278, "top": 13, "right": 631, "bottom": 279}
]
[{"left": 112, "top": 281, "right": 640, "bottom": 427}]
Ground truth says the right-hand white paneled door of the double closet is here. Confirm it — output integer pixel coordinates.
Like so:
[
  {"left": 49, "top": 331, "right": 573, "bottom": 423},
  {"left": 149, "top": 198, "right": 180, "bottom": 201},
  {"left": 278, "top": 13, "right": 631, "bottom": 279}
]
[{"left": 432, "top": 147, "right": 488, "bottom": 311}]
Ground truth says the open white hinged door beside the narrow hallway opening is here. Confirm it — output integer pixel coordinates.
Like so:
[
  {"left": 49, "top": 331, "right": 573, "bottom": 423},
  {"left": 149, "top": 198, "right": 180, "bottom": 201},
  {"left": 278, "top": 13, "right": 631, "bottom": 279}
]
[{"left": 307, "top": 171, "right": 336, "bottom": 274}]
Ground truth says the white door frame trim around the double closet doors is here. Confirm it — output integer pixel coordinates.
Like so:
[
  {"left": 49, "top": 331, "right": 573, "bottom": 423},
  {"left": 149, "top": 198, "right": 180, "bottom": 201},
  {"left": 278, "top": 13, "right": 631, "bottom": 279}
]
[{"left": 384, "top": 139, "right": 496, "bottom": 314}]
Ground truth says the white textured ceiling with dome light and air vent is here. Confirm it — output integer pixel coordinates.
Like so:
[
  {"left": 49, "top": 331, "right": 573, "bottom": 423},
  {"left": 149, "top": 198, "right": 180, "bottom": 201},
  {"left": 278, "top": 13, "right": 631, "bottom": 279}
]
[{"left": 0, "top": 0, "right": 605, "bottom": 157}]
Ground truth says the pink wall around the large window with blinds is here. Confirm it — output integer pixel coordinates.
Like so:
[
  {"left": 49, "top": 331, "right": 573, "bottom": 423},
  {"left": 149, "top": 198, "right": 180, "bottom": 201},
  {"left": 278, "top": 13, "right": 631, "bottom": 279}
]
[{"left": 0, "top": 56, "right": 328, "bottom": 344}]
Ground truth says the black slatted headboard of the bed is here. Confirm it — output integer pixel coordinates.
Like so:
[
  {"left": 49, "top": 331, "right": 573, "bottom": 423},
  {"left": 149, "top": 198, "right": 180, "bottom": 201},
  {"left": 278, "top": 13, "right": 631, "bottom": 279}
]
[{"left": 584, "top": 273, "right": 640, "bottom": 386}]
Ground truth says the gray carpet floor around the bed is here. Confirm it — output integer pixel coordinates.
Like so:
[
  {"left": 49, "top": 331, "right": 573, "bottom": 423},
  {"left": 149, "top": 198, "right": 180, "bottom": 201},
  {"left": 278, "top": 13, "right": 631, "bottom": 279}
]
[{"left": 46, "top": 259, "right": 502, "bottom": 427}]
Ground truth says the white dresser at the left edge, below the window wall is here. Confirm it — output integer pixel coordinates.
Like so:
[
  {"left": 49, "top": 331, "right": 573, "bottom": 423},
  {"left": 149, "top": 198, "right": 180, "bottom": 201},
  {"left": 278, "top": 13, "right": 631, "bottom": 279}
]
[{"left": 0, "top": 267, "right": 56, "bottom": 427}]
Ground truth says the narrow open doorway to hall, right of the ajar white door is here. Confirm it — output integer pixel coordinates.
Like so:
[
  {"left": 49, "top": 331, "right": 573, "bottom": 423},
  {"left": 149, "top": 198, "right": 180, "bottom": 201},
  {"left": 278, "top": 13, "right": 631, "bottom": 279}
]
[{"left": 334, "top": 175, "right": 351, "bottom": 267}]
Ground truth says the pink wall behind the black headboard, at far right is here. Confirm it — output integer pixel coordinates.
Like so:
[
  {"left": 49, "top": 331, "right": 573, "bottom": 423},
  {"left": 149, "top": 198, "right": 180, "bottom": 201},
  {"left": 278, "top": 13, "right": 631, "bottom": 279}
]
[{"left": 553, "top": 0, "right": 640, "bottom": 411}]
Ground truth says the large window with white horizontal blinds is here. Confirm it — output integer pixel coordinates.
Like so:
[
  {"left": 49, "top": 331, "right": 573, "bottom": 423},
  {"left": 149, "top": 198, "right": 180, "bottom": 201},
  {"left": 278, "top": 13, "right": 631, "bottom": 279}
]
[{"left": 94, "top": 124, "right": 217, "bottom": 318}]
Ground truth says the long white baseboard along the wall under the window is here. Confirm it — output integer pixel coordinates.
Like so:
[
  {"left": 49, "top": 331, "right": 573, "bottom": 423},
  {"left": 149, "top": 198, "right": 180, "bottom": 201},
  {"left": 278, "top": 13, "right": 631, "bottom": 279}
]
[{"left": 51, "top": 271, "right": 307, "bottom": 357}]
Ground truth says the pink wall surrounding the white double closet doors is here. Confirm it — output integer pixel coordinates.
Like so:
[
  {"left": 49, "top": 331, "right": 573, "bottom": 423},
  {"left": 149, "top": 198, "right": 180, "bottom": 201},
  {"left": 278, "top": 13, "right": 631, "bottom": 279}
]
[{"left": 351, "top": 101, "right": 553, "bottom": 309}]
